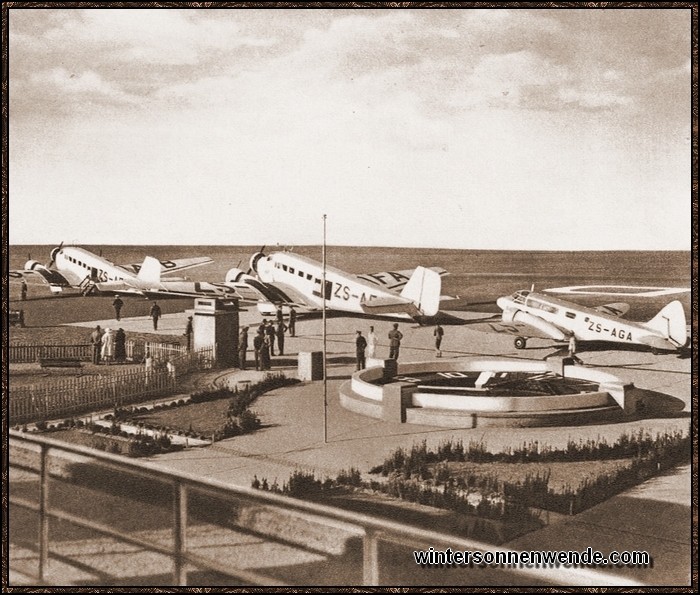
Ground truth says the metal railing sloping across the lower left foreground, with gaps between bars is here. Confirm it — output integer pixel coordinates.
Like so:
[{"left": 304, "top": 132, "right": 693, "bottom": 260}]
[{"left": 9, "top": 431, "right": 639, "bottom": 586}]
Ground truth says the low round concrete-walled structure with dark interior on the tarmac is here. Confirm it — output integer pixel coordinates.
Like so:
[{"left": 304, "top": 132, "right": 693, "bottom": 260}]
[{"left": 340, "top": 358, "right": 634, "bottom": 428}]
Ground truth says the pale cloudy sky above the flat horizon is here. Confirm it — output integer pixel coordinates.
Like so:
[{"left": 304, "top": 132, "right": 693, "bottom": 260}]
[{"left": 8, "top": 8, "right": 691, "bottom": 250}]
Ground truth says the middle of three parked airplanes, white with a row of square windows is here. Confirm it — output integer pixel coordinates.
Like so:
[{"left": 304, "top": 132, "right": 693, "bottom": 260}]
[{"left": 227, "top": 251, "right": 447, "bottom": 320}]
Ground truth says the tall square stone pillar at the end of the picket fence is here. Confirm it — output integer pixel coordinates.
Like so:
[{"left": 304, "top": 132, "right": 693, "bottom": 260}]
[{"left": 192, "top": 298, "right": 238, "bottom": 368}]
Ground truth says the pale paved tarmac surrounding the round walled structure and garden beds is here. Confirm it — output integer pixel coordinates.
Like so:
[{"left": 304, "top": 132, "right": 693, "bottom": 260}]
[{"left": 61, "top": 311, "right": 692, "bottom": 585}]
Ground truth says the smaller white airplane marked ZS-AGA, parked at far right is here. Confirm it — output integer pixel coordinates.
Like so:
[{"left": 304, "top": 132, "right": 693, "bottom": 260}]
[{"left": 489, "top": 290, "right": 687, "bottom": 352}]
